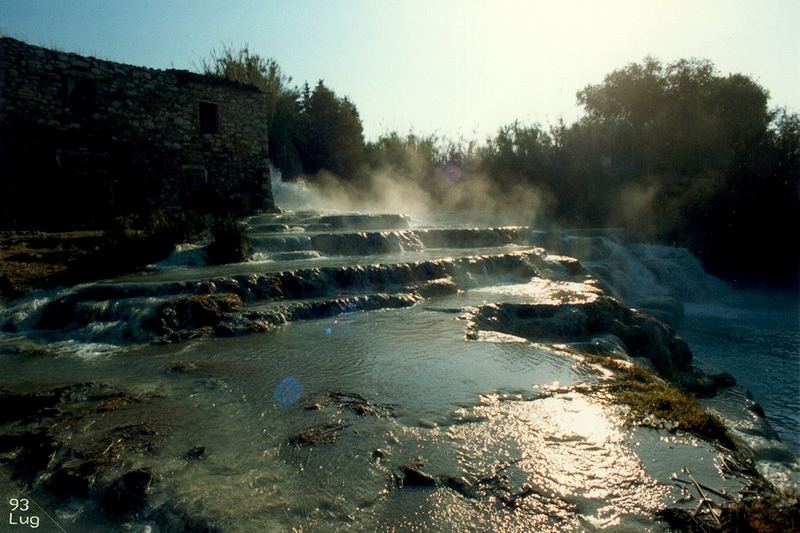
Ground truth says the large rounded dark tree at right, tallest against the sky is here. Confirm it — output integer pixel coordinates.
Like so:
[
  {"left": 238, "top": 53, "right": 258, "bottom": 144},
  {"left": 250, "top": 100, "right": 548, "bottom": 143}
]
[{"left": 572, "top": 58, "right": 800, "bottom": 280}]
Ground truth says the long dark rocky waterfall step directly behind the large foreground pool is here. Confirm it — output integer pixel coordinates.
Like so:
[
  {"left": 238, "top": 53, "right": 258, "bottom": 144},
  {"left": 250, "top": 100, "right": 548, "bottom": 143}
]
[{"left": 9, "top": 248, "right": 580, "bottom": 344}]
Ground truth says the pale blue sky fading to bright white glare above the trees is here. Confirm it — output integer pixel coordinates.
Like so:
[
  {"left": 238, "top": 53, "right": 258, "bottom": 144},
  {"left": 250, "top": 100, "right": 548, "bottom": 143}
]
[{"left": 0, "top": 0, "right": 800, "bottom": 140}]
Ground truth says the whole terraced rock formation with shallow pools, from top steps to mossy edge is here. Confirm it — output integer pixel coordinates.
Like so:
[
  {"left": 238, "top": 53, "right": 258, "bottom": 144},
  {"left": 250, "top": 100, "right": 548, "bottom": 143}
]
[{"left": 0, "top": 211, "right": 797, "bottom": 532}]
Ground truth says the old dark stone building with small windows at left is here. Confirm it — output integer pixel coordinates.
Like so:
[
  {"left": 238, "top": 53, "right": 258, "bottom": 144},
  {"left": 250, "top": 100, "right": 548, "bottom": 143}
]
[{"left": 0, "top": 37, "right": 273, "bottom": 225}]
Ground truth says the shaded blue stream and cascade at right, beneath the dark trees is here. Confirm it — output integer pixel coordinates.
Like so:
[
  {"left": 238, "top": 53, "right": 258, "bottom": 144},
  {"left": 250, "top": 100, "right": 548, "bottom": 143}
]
[{"left": 535, "top": 231, "right": 800, "bottom": 452}]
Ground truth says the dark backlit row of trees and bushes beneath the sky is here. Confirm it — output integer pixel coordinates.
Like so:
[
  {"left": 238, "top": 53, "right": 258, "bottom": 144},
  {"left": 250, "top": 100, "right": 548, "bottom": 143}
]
[{"left": 207, "top": 50, "right": 800, "bottom": 283}]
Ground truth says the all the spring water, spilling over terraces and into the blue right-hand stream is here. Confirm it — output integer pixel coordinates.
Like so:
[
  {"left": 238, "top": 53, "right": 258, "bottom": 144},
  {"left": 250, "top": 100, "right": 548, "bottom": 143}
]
[{"left": 0, "top": 194, "right": 799, "bottom": 532}]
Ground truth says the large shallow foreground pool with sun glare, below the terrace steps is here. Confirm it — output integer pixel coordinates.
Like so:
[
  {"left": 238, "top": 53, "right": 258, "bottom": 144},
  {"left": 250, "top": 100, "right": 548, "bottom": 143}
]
[{"left": 0, "top": 284, "right": 752, "bottom": 531}]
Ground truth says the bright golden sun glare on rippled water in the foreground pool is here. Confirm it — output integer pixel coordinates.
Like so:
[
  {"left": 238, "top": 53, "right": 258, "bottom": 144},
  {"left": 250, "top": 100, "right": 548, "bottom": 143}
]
[{"left": 434, "top": 392, "right": 670, "bottom": 530}]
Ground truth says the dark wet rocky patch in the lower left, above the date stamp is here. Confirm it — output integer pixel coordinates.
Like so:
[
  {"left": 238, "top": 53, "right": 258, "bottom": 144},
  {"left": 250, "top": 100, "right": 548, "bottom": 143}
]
[{"left": 0, "top": 382, "right": 172, "bottom": 516}]
